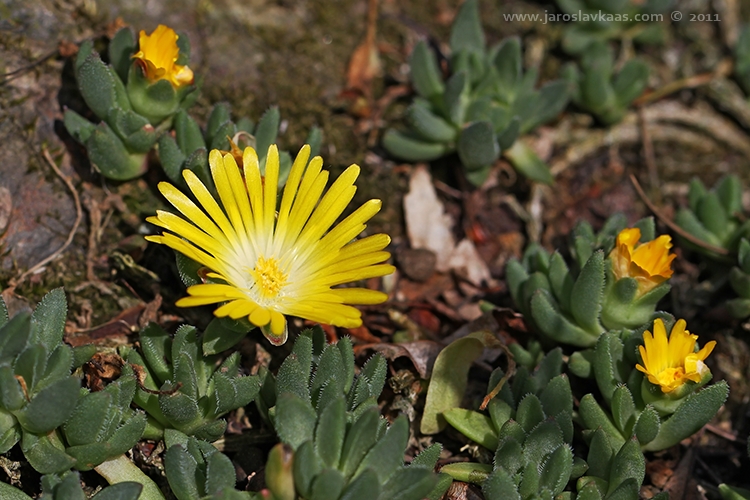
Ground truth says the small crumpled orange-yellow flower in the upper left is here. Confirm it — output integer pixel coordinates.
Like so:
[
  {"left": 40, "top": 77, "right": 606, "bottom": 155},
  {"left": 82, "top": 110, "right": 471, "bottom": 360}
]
[{"left": 133, "top": 24, "right": 193, "bottom": 88}]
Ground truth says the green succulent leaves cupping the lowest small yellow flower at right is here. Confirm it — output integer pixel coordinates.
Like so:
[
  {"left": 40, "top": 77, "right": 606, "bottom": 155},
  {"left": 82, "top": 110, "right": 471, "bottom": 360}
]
[{"left": 579, "top": 326, "right": 729, "bottom": 451}]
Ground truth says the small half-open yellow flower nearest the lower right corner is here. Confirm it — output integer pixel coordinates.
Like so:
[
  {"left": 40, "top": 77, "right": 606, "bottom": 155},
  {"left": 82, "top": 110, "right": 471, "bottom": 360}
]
[{"left": 635, "top": 319, "right": 716, "bottom": 393}]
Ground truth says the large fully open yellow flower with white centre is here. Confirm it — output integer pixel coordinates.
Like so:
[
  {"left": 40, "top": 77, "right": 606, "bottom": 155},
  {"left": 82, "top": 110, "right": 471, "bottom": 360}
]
[{"left": 147, "top": 146, "right": 394, "bottom": 344}]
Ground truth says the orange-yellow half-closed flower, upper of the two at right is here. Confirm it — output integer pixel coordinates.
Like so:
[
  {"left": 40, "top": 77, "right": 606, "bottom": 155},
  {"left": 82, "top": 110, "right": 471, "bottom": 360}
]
[{"left": 609, "top": 227, "right": 676, "bottom": 295}]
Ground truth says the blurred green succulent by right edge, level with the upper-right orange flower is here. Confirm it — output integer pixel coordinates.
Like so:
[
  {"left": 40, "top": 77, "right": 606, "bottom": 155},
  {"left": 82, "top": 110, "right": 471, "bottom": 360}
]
[{"left": 675, "top": 175, "right": 750, "bottom": 262}]
